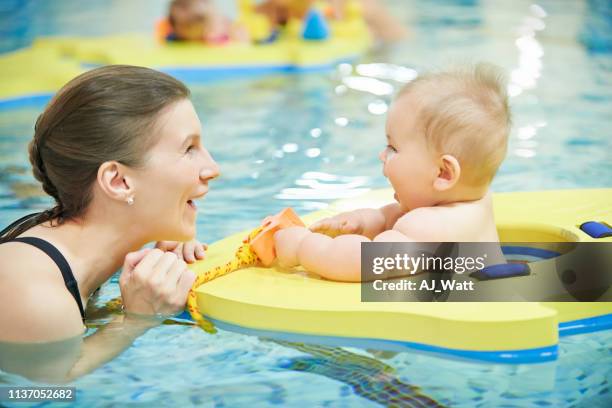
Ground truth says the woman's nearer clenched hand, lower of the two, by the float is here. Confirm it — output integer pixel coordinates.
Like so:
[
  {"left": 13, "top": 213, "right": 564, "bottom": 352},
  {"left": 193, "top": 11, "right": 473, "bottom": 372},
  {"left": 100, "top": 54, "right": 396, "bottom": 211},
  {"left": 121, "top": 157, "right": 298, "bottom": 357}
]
[{"left": 119, "top": 248, "right": 196, "bottom": 315}]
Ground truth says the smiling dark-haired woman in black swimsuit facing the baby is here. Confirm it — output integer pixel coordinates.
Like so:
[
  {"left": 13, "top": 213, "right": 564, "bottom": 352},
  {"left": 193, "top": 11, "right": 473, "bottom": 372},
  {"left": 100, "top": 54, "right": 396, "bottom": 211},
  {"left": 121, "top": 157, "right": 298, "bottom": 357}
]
[{"left": 0, "top": 66, "right": 219, "bottom": 379}]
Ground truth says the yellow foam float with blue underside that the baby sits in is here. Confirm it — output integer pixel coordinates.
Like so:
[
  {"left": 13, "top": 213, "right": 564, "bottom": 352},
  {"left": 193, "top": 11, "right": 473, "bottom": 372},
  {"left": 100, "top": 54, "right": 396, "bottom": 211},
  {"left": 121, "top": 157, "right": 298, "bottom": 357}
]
[{"left": 194, "top": 189, "right": 612, "bottom": 363}]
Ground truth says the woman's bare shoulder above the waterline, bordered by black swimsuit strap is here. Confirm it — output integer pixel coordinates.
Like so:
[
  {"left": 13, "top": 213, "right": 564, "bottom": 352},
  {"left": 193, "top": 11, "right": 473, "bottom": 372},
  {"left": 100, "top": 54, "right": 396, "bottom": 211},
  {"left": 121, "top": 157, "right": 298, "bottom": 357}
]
[{"left": 0, "top": 242, "right": 83, "bottom": 342}]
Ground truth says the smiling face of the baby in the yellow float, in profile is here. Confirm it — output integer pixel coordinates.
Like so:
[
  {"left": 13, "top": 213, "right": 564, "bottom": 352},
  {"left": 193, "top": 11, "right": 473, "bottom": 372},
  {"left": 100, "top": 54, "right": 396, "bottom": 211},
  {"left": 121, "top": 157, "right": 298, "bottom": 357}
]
[{"left": 379, "top": 96, "right": 438, "bottom": 211}]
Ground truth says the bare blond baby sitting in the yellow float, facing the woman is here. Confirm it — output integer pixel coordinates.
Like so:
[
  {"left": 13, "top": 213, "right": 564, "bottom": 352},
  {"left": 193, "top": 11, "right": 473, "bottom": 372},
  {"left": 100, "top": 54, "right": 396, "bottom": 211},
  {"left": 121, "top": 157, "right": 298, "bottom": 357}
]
[{"left": 274, "top": 64, "right": 510, "bottom": 282}]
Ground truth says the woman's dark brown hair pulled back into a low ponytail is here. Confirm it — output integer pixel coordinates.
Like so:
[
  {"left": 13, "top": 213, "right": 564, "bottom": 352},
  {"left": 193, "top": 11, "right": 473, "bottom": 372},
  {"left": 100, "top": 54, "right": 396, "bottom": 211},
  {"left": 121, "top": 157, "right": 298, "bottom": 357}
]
[{"left": 0, "top": 65, "right": 190, "bottom": 243}]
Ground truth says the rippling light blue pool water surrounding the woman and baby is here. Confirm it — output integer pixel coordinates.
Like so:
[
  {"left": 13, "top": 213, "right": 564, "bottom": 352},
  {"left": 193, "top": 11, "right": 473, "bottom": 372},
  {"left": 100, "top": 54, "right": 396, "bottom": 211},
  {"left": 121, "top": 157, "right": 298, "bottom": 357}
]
[{"left": 0, "top": 0, "right": 612, "bottom": 407}]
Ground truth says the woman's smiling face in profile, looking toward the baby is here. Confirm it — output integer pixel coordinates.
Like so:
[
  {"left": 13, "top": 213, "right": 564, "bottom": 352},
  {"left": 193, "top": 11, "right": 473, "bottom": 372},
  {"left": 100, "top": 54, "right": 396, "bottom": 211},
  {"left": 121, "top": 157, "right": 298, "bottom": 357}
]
[{"left": 133, "top": 99, "right": 219, "bottom": 241}]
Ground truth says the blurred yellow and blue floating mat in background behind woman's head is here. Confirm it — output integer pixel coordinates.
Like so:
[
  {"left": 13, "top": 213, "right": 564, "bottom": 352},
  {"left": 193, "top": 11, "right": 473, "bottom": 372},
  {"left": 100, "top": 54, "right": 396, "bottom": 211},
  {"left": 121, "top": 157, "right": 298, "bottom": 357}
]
[{"left": 0, "top": 19, "right": 372, "bottom": 103}]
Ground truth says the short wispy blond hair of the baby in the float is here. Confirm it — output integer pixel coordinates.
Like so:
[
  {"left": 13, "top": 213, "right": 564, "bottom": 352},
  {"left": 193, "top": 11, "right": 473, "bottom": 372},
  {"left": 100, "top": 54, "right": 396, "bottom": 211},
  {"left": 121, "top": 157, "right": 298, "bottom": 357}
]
[{"left": 398, "top": 63, "right": 511, "bottom": 186}]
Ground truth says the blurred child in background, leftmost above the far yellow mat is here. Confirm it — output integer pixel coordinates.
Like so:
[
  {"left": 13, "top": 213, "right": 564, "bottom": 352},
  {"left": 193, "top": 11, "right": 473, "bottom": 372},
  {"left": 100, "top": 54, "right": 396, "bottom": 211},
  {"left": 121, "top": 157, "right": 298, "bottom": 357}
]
[{"left": 167, "top": 0, "right": 248, "bottom": 44}]
